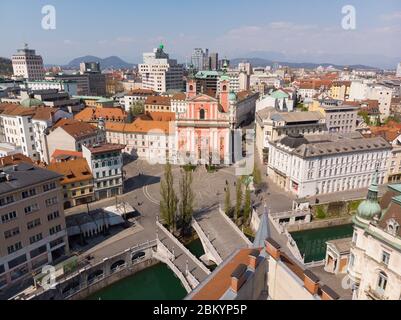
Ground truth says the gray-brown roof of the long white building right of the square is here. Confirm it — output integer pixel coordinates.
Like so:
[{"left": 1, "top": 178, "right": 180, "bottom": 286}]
[{"left": 275, "top": 132, "right": 391, "bottom": 158}]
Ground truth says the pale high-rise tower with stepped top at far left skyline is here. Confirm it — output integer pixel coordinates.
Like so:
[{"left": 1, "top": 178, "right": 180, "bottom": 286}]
[{"left": 12, "top": 44, "right": 45, "bottom": 80}]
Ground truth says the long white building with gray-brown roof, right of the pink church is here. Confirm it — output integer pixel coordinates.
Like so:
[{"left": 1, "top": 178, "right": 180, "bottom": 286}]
[{"left": 267, "top": 132, "right": 391, "bottom": 198}]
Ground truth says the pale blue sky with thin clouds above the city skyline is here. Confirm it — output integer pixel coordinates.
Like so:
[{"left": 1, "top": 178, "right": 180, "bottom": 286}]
[{"left": 0, "top": 0, "right": 401, "bottom": 64}]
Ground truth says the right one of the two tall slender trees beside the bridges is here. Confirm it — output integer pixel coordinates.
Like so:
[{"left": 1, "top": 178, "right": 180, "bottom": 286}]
[{"left": 179, "top": 170, "right": 195, "bottom": 236}]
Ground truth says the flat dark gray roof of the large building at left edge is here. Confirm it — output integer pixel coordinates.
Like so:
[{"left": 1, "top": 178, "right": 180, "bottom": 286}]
[{"left": 0, "top": 163, "right": 62, "bottom": 195}]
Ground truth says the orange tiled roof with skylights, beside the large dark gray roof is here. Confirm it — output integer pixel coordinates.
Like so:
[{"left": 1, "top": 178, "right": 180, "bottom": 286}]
[{"left": 47, "top": 159, "right": 93, "bottom": 184}]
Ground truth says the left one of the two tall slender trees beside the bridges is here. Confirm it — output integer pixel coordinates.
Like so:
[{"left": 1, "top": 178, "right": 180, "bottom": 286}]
[{"left": 160, "top": 162, "right": 178, "bottom": 232}]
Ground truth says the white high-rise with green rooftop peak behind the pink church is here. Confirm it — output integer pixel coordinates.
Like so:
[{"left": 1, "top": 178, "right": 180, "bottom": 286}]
[{"left": 138, "top": 45, "right": 184, "bottom": 93}]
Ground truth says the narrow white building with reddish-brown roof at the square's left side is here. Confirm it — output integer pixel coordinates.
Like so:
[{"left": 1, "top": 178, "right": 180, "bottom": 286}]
[{"left": 82, "top": 143, "right": 125, "bottom": 200}]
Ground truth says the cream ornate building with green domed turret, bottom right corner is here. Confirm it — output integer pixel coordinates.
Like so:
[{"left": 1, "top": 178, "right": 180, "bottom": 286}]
[{"left": 348, "top": 181, "right": 401, "bottom": 301}]
